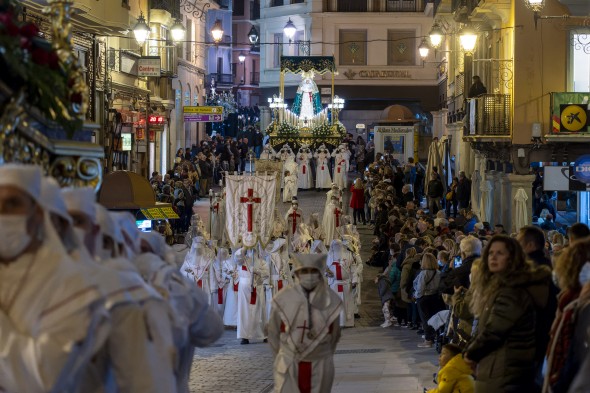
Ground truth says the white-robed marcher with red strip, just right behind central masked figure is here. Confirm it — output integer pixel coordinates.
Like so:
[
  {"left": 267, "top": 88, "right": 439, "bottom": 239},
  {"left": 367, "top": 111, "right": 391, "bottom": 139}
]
[{"left": 326, "top": 240, "right": 358, "bottom": 327}]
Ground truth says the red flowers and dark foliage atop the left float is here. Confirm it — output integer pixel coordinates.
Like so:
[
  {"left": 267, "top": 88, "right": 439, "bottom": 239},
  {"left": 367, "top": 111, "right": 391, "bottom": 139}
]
[{"left": 0, "top": 0, "right": 87, "bottom": 137}]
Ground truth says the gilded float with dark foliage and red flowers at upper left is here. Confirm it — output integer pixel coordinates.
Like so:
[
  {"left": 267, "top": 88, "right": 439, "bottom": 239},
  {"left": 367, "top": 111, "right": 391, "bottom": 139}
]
[{"left": 0, "top": 0, "right": 104, "bottom": 189}]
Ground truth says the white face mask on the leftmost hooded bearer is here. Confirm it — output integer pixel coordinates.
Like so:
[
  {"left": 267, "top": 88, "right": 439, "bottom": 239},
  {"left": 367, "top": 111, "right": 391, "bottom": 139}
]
[{"left": 0, "top": 214, "right": 32, "bottom": 261}]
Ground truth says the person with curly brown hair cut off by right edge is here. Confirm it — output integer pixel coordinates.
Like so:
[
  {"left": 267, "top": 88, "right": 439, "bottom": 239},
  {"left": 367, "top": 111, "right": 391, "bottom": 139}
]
[{"left": 543, "top": 238, "right": 590, "bottom": 392}]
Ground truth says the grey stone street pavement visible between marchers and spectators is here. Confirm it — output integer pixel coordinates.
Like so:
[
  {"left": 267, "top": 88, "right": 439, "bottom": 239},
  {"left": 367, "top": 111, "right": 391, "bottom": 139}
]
[{"left": 190, "top": 182, "right": 438, "bottom": 393}]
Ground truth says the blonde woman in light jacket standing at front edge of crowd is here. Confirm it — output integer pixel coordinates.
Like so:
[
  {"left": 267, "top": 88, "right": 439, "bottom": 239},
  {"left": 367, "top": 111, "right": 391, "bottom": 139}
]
[{"left": 414, "top": 253, "right": 445, "bottom": 348}]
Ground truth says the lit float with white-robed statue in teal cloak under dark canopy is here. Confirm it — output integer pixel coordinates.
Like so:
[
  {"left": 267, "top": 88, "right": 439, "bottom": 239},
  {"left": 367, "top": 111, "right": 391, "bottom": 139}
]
[{"left": 266, "top": 56, "right": 346, "bottom": 149}]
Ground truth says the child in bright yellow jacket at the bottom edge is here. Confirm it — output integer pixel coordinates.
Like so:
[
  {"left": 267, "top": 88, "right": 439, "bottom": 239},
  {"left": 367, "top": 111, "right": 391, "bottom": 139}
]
[{"left": 427, "top": 344, "right": 475, "bottom": 393}]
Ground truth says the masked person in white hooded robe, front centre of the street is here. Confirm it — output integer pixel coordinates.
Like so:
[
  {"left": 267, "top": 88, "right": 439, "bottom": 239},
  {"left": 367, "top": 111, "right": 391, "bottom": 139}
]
[{"left": 268, "top": 254, "right": 342, "bottom": 393}]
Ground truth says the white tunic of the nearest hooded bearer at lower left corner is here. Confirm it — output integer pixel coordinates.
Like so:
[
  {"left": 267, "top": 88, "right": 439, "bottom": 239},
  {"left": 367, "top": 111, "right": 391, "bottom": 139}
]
[{"left": 0, "top": 241, "right": 110, "bottom": 393}]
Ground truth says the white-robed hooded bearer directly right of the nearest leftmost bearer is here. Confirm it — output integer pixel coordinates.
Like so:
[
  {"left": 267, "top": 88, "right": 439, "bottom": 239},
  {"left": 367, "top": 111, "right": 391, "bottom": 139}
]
[{"left": 62, "top": 187, "right": 178, "bottom": 392}]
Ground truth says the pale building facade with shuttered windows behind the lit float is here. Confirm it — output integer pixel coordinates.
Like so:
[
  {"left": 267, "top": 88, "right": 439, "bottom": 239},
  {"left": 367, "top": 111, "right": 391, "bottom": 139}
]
[{"left": 259, "top": 0, "right": 438, "bottom": 137}]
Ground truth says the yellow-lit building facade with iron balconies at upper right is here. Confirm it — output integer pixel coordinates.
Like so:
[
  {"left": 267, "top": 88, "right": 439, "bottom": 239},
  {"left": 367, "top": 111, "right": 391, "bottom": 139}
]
[{"left": 429, "top": 0, "right": 590, "bottom": 231}]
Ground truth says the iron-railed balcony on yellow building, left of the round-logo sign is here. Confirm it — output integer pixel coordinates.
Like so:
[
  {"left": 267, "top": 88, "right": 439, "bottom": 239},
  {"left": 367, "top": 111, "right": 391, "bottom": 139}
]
[{"left": 465, "top": 94, "right": 512, "bottom": 137}]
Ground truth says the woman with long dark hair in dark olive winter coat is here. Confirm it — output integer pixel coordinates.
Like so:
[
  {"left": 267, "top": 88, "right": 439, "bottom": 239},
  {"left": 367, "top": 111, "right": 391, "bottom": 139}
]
[{"left": 464, "top": 235, "right": 551, "bottom": 393}]
